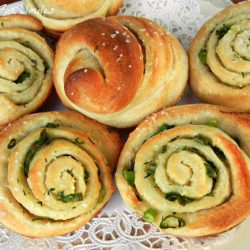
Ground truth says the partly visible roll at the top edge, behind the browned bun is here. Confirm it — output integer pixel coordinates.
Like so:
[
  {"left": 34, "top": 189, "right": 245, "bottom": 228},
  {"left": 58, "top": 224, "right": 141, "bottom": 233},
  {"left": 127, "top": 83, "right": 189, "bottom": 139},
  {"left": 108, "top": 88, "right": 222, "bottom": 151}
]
[{"left": 23, "top": 0, "right": 122, "bottom": 35}]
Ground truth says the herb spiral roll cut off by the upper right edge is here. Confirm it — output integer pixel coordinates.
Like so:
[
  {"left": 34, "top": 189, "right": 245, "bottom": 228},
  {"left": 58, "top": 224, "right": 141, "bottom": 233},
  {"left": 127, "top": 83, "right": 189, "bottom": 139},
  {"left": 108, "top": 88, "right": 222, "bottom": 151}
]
[{"left": 189, "top": 1, "right": 250, "bottom": 111}]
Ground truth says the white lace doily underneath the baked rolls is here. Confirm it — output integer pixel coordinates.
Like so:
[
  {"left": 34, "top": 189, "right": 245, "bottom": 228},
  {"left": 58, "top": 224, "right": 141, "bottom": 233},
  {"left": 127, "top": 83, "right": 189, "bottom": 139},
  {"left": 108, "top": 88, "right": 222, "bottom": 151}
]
[{"left": 0, "top": 0, "right": 242, "bottom": 250}]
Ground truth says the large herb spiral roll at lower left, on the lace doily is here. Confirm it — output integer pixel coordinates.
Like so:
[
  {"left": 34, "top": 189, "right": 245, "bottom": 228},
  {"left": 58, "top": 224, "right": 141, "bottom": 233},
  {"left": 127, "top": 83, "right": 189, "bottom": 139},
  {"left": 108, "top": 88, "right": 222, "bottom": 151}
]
[{"left": 0, "top": 112, "right": 121, "bottom": 238}]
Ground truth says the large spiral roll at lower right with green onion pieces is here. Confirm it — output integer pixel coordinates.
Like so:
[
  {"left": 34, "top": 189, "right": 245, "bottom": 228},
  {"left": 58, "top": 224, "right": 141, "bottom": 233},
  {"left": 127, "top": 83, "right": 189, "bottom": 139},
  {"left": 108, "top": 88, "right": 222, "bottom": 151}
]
[{"left": 116, "top": 104, "right": 250, "bottom": 237}]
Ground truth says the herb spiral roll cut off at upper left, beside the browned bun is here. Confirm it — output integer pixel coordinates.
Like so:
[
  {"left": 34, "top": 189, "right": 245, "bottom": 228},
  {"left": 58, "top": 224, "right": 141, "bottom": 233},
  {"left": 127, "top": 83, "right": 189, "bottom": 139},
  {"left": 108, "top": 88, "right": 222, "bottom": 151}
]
[{"left": 0, "top": 15, "right": 53, "bottom": 126}]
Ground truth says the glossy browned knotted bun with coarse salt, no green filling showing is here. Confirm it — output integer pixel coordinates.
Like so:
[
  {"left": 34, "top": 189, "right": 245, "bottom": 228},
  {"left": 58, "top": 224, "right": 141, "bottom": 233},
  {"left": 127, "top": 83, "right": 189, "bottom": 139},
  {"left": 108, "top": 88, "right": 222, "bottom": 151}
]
[{"left": 54, "top": 16, "right": 188, "bottom": 128}]
